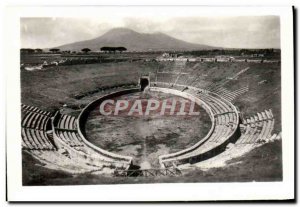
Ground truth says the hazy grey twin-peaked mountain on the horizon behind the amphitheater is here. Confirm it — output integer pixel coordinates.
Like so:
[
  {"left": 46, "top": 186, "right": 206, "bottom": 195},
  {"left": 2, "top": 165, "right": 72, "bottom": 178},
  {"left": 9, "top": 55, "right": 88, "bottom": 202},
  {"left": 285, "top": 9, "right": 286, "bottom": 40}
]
[{"left": 51, "top": 28, "right": 215, "bottom": 51}]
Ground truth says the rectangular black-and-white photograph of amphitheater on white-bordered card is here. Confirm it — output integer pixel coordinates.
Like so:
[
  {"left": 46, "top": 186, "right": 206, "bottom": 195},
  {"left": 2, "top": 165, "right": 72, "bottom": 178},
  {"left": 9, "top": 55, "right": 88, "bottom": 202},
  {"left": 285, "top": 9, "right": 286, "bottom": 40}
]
[{"left": 7, "top": 7, "right": 294, "bottom": 200}]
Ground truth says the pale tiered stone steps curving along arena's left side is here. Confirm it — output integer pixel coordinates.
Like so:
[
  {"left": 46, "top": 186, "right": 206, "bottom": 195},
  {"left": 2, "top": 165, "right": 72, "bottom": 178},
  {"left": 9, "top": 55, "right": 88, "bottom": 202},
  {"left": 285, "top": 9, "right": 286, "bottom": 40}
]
[{"left": 21, "top": 104, "right": 130, "bottom": 174}]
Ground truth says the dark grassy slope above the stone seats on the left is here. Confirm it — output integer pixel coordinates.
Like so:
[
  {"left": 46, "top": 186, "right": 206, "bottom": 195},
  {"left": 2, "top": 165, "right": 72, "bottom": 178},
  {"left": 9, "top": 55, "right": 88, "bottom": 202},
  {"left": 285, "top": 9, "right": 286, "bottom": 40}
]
[{"left": 21, "top": 62, "right": 156, "bottom": 111}]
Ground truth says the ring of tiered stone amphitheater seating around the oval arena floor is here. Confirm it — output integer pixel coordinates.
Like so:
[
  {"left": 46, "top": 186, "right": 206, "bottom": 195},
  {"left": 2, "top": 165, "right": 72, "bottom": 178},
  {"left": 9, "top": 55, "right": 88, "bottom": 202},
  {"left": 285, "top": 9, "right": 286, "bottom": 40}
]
[{"left": 21, "top": 58, "right": 281, "bottom": 181}]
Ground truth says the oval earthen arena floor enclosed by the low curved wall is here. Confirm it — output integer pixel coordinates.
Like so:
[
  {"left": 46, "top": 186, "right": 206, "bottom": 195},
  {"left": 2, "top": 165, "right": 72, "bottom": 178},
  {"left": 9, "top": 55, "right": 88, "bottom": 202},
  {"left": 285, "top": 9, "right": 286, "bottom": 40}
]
[{"left": 85, "top": 91, "right": 211, "bottom": 168}]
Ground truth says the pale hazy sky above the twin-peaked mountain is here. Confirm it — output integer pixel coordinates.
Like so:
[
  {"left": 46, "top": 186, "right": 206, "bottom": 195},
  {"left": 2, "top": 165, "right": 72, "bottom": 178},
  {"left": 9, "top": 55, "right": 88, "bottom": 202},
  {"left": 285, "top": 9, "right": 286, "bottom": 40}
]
[{"left": 21, "top": 16, "right": 280, "bottom": 48}]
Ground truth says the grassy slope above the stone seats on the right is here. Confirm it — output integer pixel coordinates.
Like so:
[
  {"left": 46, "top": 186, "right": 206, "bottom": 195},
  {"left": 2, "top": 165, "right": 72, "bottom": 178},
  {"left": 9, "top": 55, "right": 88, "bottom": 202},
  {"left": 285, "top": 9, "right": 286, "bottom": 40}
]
[{"left": 178, "top": 62, "right": 281, "bottom": 132}]
